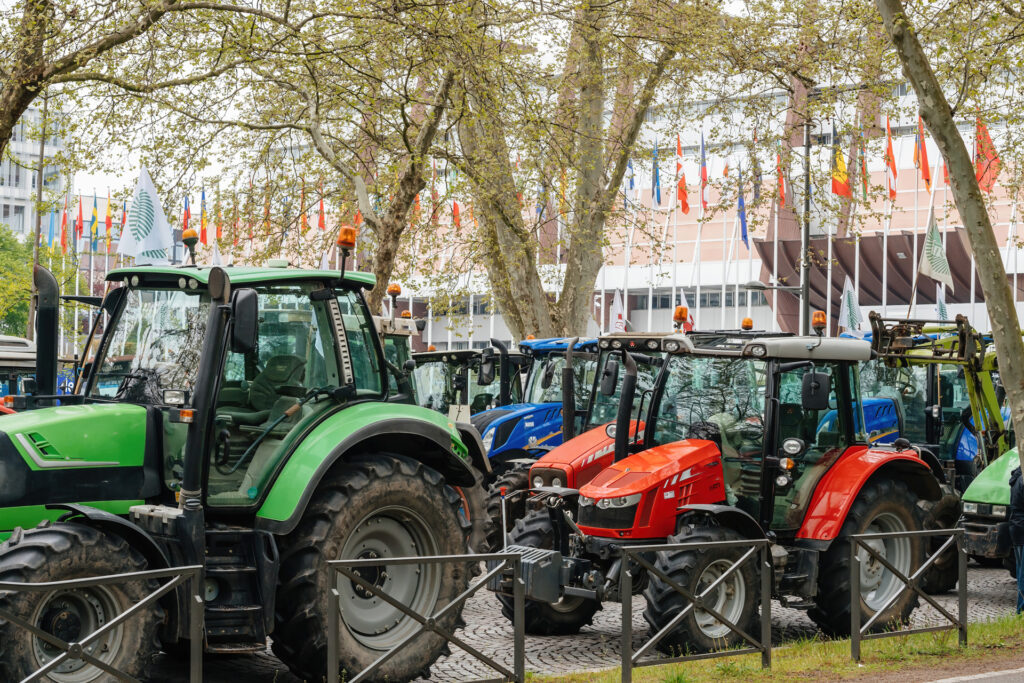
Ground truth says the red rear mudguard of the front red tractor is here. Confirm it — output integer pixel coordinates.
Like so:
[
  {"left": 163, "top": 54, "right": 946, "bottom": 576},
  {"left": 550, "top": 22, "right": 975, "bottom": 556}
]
[{"left": 797, "top": 445, "right": 942, "bottom": 543}]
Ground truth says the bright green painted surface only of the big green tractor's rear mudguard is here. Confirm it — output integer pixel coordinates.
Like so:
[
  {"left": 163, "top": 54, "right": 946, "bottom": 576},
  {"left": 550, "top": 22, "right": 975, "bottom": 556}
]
[{"left": 256, "top": 401, "right": 468, "bottom": 521}]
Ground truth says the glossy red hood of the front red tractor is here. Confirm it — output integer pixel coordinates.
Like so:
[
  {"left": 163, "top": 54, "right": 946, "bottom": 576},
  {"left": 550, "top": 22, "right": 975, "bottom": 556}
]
[{"left": 580, "top": 438, "right": 722, "bottom": 500}]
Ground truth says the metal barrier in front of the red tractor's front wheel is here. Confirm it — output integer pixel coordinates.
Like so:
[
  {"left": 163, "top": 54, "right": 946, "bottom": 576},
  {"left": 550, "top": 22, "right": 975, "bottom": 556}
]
[{"left": 618, "top": 539, "right": 772, "bottom": 683}]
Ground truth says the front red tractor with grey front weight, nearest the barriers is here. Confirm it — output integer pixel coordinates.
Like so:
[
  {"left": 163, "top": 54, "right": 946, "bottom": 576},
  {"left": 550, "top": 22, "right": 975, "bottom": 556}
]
[{"left": 499, "top": 332, "right": 941, "bottom": 652}]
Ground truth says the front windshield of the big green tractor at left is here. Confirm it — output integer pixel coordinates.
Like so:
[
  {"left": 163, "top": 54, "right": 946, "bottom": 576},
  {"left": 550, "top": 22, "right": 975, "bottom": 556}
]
[{"left": 89, "top": 288, "right": 210, "bottom": 404}]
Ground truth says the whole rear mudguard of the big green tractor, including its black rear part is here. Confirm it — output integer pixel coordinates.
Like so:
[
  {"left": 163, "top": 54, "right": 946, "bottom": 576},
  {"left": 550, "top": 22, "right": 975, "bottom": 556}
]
[{"left": 256, "top": 402, "right": 475, "bottom": 533}]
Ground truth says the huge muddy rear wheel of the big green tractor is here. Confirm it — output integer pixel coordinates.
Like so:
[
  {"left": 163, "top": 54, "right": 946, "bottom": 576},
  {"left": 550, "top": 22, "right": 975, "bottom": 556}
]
[{"left": 271, "top": 454, "right": 468, "bottom": 681}]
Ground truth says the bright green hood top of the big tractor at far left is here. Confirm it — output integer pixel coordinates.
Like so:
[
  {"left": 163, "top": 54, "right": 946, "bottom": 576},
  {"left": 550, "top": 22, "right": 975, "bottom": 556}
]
[{"left": 0, "top": 403, "right": 146, "bottom": 470}]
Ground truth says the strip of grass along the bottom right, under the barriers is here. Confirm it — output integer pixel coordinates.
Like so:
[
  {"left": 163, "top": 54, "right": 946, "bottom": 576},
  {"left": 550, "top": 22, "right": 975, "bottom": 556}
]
[{"left": 531, "top": 615, "right": 1024, "bottom": 683}]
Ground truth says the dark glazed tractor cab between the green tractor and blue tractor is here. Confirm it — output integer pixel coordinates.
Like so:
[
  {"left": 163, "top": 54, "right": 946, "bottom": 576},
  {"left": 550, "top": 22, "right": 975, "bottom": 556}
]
[{"left": 413, "top": 339, "right": 526, "bottom": 422}]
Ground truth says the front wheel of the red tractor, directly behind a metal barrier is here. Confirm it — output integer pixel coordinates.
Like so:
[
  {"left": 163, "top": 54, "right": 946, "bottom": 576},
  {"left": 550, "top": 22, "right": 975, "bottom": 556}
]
[{"left": 643, "top": 526, "right": 759, "bottom": 655}]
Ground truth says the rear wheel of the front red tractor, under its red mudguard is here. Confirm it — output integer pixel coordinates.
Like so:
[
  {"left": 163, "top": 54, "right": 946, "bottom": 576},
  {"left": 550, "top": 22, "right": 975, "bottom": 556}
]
[{"left": 807, "top": 479, "right": 924, "bottom": 638}]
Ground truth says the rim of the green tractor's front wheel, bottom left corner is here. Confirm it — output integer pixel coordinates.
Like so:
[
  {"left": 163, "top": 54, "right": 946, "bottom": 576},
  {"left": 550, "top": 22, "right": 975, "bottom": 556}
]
[{"left": 32, "top": 586, "right": 124, "bottom": 683}]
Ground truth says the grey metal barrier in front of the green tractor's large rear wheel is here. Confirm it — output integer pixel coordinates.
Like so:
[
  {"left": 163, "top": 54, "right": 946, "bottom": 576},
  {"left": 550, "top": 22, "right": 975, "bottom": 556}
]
[{"left": 327, "top": 553, "right": 526, "bottom": 683}]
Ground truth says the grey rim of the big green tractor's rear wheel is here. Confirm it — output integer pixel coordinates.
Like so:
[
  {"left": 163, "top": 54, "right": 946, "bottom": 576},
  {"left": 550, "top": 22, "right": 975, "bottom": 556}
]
[{"left": 337, "top": 506, "right": 441, "bottom": 650}]
